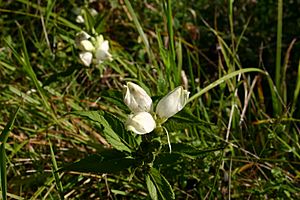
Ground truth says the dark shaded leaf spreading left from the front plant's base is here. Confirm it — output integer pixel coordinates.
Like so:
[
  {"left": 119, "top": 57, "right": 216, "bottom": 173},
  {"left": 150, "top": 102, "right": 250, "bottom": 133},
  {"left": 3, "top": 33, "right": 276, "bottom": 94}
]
[{"left": 61, "top": 149, "right": 136, "bottom": 173}]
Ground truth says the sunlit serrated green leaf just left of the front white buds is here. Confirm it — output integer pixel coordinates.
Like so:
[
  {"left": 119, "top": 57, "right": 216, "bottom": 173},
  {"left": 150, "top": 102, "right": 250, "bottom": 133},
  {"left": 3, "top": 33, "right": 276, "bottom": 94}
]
[{"left": 70, "top": 111, "right": 131, "bottom": 152}]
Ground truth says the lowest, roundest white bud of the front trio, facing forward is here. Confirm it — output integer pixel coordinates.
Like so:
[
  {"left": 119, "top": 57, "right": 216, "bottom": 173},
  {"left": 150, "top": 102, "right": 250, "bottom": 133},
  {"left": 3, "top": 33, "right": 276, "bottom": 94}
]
[{"left": 125, "top": 112, "right": 156, "bottom": 134}]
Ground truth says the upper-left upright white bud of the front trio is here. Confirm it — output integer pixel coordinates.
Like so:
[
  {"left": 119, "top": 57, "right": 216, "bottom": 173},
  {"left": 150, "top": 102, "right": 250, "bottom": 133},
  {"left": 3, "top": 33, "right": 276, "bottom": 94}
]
[{"left": 124, "top": 82, "right": 152, "bottom": 113}]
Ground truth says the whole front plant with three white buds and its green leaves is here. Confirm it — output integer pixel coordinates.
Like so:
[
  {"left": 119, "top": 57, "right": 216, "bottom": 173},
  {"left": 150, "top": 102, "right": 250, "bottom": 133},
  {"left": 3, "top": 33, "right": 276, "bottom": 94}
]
[{"left": 64, "top": 82, "right": 195, "bottom": 199}]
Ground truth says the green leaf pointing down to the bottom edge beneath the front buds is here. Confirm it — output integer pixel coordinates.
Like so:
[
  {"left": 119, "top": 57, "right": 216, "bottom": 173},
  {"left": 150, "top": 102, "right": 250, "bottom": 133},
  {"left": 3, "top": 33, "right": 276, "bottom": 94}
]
[{"left": 149, "top": 168, "right": 175, "bottom": 200}]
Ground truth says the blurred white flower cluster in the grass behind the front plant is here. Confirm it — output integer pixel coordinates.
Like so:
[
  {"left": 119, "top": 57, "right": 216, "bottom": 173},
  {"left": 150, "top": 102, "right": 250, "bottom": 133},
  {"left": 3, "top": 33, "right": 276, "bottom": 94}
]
[{"left": 76, "top": 31, "right": 112, "bottom": 66}]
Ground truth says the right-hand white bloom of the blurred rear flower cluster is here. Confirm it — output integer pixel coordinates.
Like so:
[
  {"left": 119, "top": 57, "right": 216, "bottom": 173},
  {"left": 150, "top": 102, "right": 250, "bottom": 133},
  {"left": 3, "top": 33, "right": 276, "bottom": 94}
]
[{"left": 95, "top": 35, "right": 112, "bottom": 63}]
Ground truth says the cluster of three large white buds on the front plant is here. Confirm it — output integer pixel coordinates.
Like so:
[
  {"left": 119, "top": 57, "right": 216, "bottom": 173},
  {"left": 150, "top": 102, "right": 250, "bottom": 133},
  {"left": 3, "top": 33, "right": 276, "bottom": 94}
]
[{"left": 124, "top": 82, "right": 189, "bottom": 134}]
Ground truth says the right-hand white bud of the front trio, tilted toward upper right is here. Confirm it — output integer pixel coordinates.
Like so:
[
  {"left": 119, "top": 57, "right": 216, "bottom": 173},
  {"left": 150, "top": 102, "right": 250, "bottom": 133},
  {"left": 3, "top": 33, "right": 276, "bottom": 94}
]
[{"left": 156, "top": 86, "right": 190, "bottom": 122}]
